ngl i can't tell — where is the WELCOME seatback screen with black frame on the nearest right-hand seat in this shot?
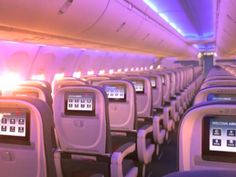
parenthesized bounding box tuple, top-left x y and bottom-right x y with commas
(202, 116, 236, 162)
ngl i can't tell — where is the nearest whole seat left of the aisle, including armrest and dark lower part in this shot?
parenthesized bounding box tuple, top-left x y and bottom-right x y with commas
(53, 85, 138, 177)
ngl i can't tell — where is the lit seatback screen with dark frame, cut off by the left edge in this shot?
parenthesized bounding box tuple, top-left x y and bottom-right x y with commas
(0, 108, 30, 145)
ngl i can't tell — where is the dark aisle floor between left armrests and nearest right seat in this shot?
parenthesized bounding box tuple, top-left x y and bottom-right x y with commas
(147, 128, 178, 177)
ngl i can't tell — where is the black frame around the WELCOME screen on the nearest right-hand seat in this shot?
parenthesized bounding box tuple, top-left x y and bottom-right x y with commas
(201, 115, 236, 163)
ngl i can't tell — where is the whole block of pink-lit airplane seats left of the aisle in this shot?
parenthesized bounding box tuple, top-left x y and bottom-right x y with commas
(0, 67, 203, 177)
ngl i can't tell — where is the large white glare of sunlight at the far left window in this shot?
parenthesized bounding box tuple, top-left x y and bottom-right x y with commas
(0, 72, 22, 95)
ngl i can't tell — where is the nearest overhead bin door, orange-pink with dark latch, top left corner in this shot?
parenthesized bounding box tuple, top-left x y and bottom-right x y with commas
(0, 0, 109, 36)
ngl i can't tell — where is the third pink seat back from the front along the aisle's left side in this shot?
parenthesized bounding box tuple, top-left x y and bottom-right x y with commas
(125, 76, 152, 117)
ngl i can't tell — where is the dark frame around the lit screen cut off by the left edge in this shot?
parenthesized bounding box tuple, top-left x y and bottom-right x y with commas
(0, 108, 30, 145)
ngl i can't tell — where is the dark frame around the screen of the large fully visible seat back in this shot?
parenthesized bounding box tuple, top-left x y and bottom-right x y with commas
(64, 92, 96, 116)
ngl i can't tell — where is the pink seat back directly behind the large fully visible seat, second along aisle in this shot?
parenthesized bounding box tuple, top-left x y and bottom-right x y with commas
(98, 80, 136, 130)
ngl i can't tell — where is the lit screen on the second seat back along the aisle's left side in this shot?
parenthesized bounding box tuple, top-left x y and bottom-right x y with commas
(104, 84, 126, 102)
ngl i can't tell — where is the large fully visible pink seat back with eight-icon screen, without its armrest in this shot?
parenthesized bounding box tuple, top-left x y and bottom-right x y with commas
(53, 85, 111, 154)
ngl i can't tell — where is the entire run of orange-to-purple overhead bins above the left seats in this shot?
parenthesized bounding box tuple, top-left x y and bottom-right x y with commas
(0, 0, 196, 56)
